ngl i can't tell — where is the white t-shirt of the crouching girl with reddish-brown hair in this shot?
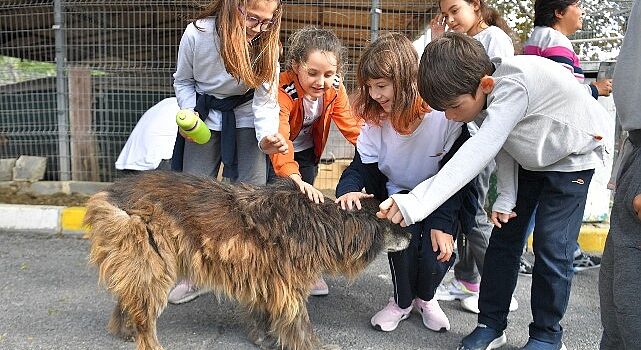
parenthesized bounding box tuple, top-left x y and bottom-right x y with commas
(356, 111, 462, 194)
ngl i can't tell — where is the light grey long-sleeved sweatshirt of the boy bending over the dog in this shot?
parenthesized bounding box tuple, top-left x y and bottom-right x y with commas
(392, 56, 613, 225)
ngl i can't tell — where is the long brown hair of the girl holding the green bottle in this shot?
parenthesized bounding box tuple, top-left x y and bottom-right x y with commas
(194, 0, 283, 88)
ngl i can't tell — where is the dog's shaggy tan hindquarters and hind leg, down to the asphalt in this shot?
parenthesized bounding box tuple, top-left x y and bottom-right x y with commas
(90, 203, 176, 350)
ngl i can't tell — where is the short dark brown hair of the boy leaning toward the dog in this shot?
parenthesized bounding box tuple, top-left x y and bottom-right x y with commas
(418, 32, 494, 111)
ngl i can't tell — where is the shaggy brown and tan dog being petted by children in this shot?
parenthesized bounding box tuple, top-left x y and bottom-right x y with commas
(85, 171, 409, 350)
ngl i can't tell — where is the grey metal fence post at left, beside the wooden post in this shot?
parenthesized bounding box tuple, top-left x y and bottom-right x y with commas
(52, 0, 71, 181)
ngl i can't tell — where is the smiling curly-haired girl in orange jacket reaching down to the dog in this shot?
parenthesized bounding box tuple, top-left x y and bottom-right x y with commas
(270, 27, 360, 295)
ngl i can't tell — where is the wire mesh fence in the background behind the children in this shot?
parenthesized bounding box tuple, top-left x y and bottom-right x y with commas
(0, 0, 438, 188)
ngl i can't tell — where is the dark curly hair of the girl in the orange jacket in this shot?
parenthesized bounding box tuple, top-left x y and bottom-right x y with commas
(285, 26, 347, 74)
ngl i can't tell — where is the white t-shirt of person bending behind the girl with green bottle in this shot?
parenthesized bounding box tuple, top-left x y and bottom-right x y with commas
(116, 97, 180, 170)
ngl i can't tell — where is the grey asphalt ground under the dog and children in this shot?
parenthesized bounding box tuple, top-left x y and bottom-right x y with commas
(0, 232, 601, 350)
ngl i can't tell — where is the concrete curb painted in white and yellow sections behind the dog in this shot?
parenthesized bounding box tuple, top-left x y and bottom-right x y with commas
(0, 204, 610, 253)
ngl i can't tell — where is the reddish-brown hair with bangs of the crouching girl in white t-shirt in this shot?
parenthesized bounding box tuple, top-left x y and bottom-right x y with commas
(354, 33, 429, 133)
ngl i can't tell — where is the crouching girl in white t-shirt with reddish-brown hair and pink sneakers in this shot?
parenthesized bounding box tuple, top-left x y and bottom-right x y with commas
(336, 33, 469, 332)
